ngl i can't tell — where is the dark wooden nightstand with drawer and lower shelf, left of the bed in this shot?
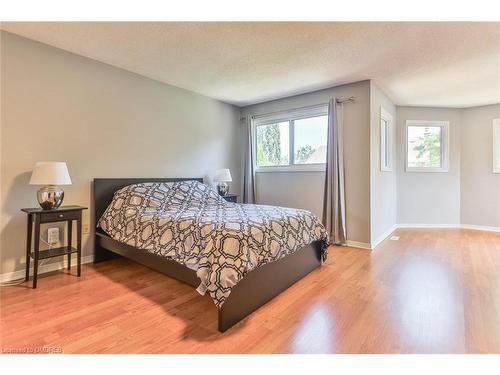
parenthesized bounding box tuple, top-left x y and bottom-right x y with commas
(21, 206, 87, 288)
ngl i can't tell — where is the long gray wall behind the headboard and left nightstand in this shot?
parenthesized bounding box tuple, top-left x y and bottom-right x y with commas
(0, 32, 241, 273)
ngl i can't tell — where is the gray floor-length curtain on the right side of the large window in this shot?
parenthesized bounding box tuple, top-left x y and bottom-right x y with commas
(323, 99, 346, 245)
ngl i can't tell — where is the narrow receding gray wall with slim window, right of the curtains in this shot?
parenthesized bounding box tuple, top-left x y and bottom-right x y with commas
(370, 81, 397, 246)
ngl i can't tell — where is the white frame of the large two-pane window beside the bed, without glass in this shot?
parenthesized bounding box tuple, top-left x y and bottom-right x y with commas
(252, 104, 328, 173)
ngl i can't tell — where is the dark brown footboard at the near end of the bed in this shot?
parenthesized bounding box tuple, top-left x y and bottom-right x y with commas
(218, 242, 321, 332)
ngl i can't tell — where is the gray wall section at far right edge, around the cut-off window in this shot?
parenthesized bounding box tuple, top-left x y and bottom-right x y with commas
(460, 104, 500, 228)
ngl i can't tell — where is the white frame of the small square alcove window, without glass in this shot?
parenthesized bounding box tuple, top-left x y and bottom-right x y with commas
(405, 120, 450, 173)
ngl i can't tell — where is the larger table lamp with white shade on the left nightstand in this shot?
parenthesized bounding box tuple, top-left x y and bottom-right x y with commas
(30, 161, 71, 210)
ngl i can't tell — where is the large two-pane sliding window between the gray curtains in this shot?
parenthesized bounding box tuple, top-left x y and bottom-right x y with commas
(254, 105, 328, 172)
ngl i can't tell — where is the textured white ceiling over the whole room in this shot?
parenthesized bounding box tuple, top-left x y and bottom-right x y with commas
(2, 22, 500, 107)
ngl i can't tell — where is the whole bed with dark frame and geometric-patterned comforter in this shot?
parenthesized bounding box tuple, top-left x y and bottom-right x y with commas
(93, 178, 327, 332)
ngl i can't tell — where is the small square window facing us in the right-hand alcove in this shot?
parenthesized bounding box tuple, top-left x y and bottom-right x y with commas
(406, 120, 449, 172)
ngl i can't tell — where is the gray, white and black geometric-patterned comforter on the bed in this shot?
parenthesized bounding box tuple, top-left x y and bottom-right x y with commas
(98, 181, 328, 308)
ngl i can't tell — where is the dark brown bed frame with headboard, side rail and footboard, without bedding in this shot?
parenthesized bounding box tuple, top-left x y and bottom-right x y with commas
(93, 178, 321, 332)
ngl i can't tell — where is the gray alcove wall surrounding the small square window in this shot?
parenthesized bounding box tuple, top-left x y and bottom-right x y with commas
(397, 107, 460, 224)
